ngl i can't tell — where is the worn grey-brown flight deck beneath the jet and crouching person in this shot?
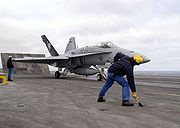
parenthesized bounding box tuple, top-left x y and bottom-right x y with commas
(0, 75, 180, 128)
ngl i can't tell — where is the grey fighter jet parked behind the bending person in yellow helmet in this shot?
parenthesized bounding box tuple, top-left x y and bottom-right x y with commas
(13, 35, 150, 80)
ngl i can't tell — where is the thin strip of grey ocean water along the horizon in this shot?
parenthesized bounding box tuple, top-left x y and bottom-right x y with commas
(134, 71, 180, 77)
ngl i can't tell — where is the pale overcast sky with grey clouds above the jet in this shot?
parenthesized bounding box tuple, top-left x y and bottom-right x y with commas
(0, 0, 180, 71)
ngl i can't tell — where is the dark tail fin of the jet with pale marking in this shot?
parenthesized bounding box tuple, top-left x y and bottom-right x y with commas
(41, 35, 59, 56)
